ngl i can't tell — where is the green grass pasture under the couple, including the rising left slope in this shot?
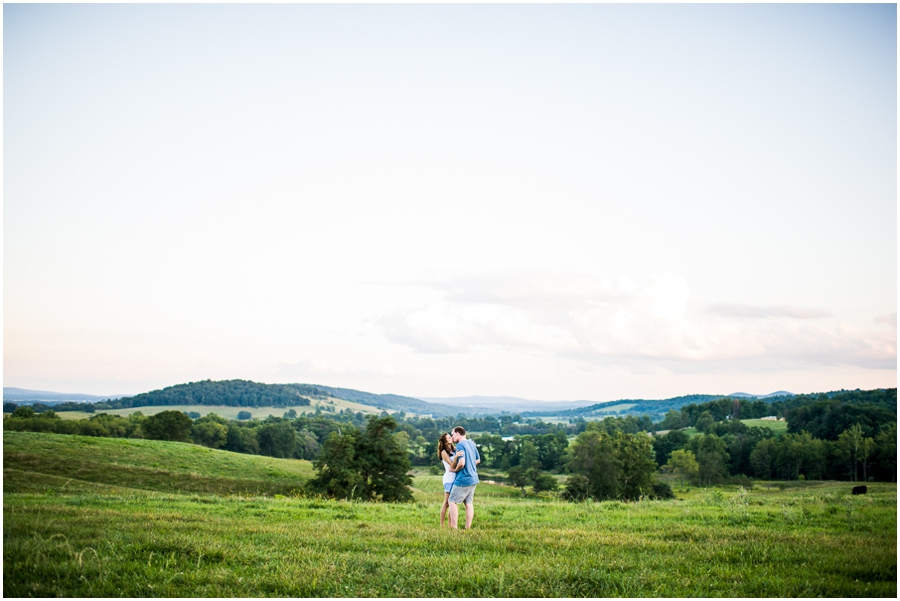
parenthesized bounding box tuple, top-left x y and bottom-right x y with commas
(3, 432, 897, 598)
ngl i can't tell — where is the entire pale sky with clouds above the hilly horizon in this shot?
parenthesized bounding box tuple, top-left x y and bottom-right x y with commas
(3, 4, 897, 402)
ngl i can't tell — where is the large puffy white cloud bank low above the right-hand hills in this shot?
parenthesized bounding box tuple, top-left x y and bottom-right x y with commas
(378, 274, 897, 371)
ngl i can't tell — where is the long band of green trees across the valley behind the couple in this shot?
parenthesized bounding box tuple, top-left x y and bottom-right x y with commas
(4, 389, 897, 500)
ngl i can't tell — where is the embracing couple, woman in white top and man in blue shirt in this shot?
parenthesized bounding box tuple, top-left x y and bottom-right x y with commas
(438, 426, 481, 530)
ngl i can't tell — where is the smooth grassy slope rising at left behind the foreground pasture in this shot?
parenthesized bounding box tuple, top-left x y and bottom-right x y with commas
(3, 431, 313, 494)
